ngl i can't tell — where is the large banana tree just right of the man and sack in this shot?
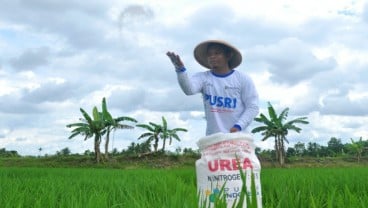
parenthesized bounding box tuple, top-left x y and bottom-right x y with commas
(252, 102, 309, 166)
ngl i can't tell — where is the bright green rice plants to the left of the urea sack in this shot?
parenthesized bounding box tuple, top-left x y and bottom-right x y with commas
(0, 168, 196, 207)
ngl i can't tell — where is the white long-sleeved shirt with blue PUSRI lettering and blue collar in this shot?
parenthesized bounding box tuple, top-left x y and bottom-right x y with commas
(177, 70, 259, 135)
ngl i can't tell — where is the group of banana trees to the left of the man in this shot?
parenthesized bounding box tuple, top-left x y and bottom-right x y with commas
(66, 98, 187, 163)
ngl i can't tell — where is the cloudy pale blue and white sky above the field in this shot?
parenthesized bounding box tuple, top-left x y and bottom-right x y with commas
(0, 0, 368, 155)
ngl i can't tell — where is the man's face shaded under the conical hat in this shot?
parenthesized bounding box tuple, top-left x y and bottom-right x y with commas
(207, 45, 229, 70)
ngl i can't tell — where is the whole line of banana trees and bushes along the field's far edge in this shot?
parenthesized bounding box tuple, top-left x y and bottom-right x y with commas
(0, 98, 368, 166)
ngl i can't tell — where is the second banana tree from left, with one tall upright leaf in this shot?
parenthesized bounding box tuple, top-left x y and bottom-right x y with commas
(102, 98, 137, 160)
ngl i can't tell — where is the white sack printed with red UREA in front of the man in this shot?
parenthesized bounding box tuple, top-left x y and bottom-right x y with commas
(196, 133, 262, 208)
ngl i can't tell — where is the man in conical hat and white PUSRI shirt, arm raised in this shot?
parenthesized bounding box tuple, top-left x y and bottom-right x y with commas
(167, 40, 259, 135)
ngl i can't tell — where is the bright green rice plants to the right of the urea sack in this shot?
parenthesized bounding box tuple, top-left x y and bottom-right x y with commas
(262, 167, 368, 208)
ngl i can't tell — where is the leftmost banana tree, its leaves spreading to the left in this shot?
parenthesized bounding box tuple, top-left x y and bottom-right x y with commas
(66, 106, 105, 163)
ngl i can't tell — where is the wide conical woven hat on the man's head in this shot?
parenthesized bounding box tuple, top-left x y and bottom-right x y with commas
(194, 40, 242, 69)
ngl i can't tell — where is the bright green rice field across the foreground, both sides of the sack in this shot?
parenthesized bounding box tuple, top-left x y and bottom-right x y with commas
(0, 167, 368, 208)
